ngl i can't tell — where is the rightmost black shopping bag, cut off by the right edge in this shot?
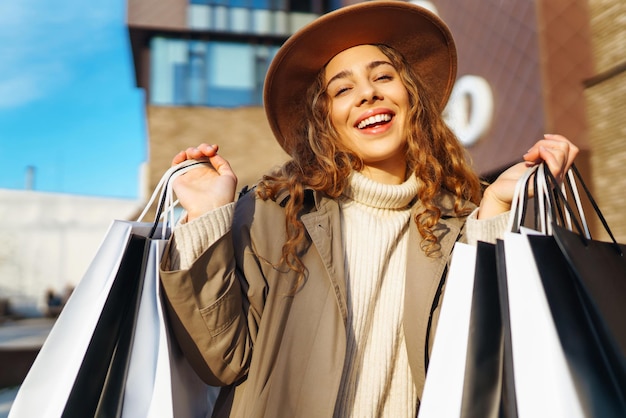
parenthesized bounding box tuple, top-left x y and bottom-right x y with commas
(535, 166, 626, 416)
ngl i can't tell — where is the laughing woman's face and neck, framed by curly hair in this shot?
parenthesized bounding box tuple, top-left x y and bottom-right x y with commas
(325, 45, 409, 183)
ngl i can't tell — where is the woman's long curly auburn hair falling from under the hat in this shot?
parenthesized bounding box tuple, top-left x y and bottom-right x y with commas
(256, 45, 482, 275)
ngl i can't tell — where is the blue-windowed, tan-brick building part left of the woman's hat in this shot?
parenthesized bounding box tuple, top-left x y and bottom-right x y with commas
(128, 0, 339, 198)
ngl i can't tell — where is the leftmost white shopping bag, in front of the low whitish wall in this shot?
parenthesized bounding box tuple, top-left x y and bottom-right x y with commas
(9, 221, 152, 418)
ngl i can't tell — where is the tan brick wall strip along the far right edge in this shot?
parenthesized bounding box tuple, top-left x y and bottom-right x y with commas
(585, 0, 626, 243)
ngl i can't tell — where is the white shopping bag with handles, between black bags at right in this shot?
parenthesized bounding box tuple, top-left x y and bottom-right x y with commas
(496, 165, 584, 417)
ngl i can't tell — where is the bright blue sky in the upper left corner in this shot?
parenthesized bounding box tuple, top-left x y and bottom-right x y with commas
(0, 0, 147, 198)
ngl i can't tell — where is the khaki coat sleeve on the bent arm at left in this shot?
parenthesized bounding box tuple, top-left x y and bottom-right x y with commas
(161, 193, 266, 386)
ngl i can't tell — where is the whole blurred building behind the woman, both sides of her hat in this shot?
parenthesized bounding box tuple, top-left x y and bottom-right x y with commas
(128, 0, 626, 242)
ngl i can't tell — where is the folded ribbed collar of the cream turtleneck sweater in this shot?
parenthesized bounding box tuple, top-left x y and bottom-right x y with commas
(343, 171, 418, 209)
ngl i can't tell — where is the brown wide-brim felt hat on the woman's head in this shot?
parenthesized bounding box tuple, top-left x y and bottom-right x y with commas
(263, 1, 457, 153)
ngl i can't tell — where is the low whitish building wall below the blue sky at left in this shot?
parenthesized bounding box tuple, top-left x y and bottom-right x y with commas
(0, 189, 141, 319)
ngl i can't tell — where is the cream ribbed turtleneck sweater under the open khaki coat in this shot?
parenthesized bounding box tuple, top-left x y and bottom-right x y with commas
(335, 172, 417, 418)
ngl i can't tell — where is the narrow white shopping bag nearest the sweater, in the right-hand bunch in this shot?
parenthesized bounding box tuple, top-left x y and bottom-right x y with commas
(418, 242, 476, 418)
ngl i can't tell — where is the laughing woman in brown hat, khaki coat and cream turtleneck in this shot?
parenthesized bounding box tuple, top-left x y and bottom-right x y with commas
(162, 2, 578, 417)
